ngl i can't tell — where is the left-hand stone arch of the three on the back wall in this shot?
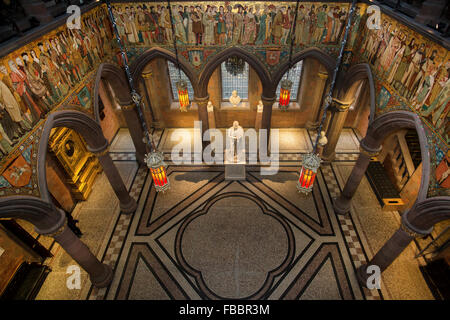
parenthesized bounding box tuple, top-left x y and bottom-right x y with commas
(130, 47, 198, 94)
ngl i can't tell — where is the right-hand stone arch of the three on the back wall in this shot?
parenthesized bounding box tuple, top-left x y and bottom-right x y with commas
(270, 48, 336, 96)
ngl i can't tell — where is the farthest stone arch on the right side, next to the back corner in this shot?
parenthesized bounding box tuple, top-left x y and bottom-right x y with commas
(337, 63, 376, 125)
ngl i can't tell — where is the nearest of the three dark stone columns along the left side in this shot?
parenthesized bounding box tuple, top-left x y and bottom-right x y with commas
(52, 223, 113, 288)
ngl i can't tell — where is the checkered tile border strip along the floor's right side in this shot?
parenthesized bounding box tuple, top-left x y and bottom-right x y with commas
(322, 165, 382, 300)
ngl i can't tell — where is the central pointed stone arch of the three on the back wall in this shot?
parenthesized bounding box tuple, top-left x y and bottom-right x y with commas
(196, 47, 272, 98)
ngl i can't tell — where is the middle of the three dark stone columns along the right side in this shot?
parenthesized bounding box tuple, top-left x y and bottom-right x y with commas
(333, 138, 381, 214)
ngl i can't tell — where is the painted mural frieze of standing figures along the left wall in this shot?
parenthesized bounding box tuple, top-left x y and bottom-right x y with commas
(0, 6, 117, 172)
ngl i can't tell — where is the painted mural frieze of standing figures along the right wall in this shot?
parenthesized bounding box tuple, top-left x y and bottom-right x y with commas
(352, 5, 450, 196)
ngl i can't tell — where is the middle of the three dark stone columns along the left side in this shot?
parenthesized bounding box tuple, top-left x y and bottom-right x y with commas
(88, 147, 137, 214)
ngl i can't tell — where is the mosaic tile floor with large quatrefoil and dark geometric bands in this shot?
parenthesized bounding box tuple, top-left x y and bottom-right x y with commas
(38, 128, 432, 300)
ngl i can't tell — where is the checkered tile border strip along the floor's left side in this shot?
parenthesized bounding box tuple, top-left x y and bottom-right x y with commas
(87, 166, 148, 300)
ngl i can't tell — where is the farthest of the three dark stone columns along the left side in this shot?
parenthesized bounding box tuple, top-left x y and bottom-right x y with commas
(119, 101, 147, 164)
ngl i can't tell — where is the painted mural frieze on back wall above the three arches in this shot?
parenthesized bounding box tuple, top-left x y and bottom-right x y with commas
(113, 1, 349, 72)
